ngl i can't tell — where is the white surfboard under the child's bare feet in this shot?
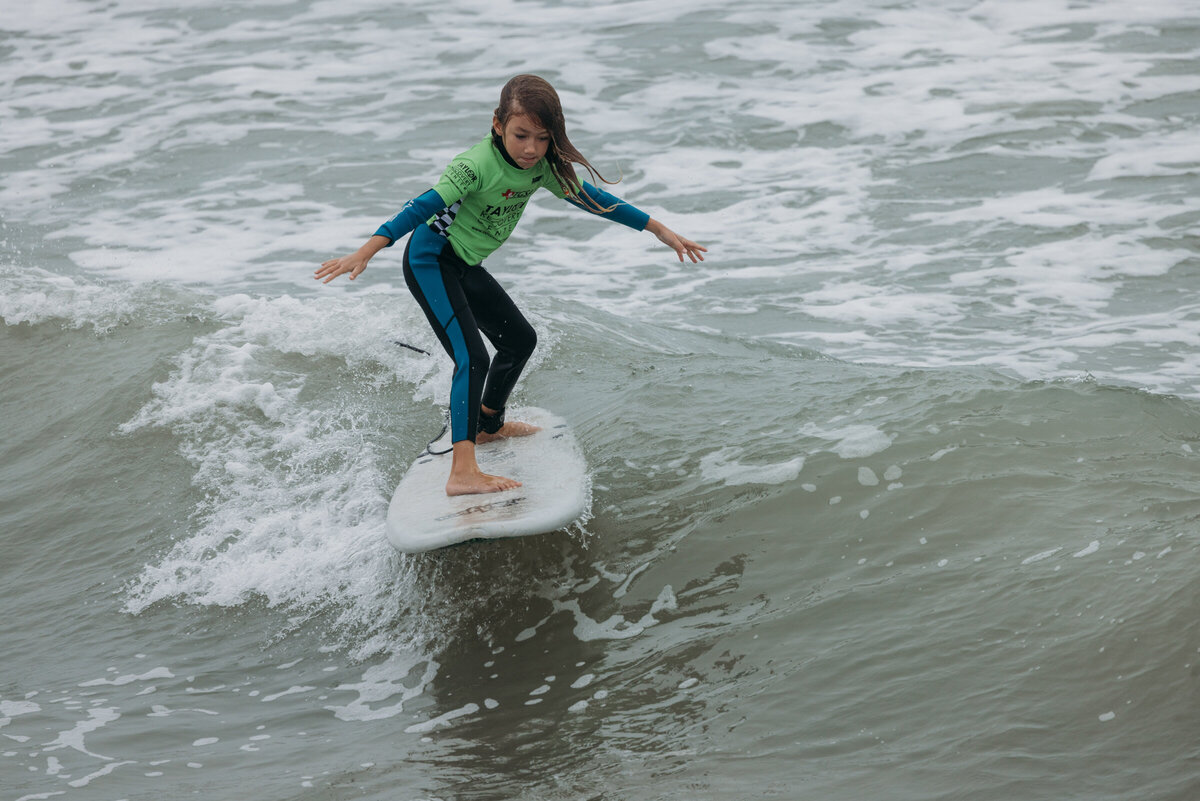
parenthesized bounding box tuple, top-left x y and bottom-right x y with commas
(386, 406, 590, 554)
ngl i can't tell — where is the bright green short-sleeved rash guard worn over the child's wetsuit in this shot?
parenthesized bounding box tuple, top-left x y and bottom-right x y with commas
(430, 134, 566, 264)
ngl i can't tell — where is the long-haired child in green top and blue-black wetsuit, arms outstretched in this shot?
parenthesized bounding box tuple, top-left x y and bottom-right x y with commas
(316, 76, 707, 495)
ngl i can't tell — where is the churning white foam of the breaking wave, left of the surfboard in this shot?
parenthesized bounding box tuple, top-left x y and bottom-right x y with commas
(121, 294, 525, 651)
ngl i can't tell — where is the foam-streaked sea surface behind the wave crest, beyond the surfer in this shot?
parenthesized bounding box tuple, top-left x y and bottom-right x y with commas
(7, 0, 1200, 395)
